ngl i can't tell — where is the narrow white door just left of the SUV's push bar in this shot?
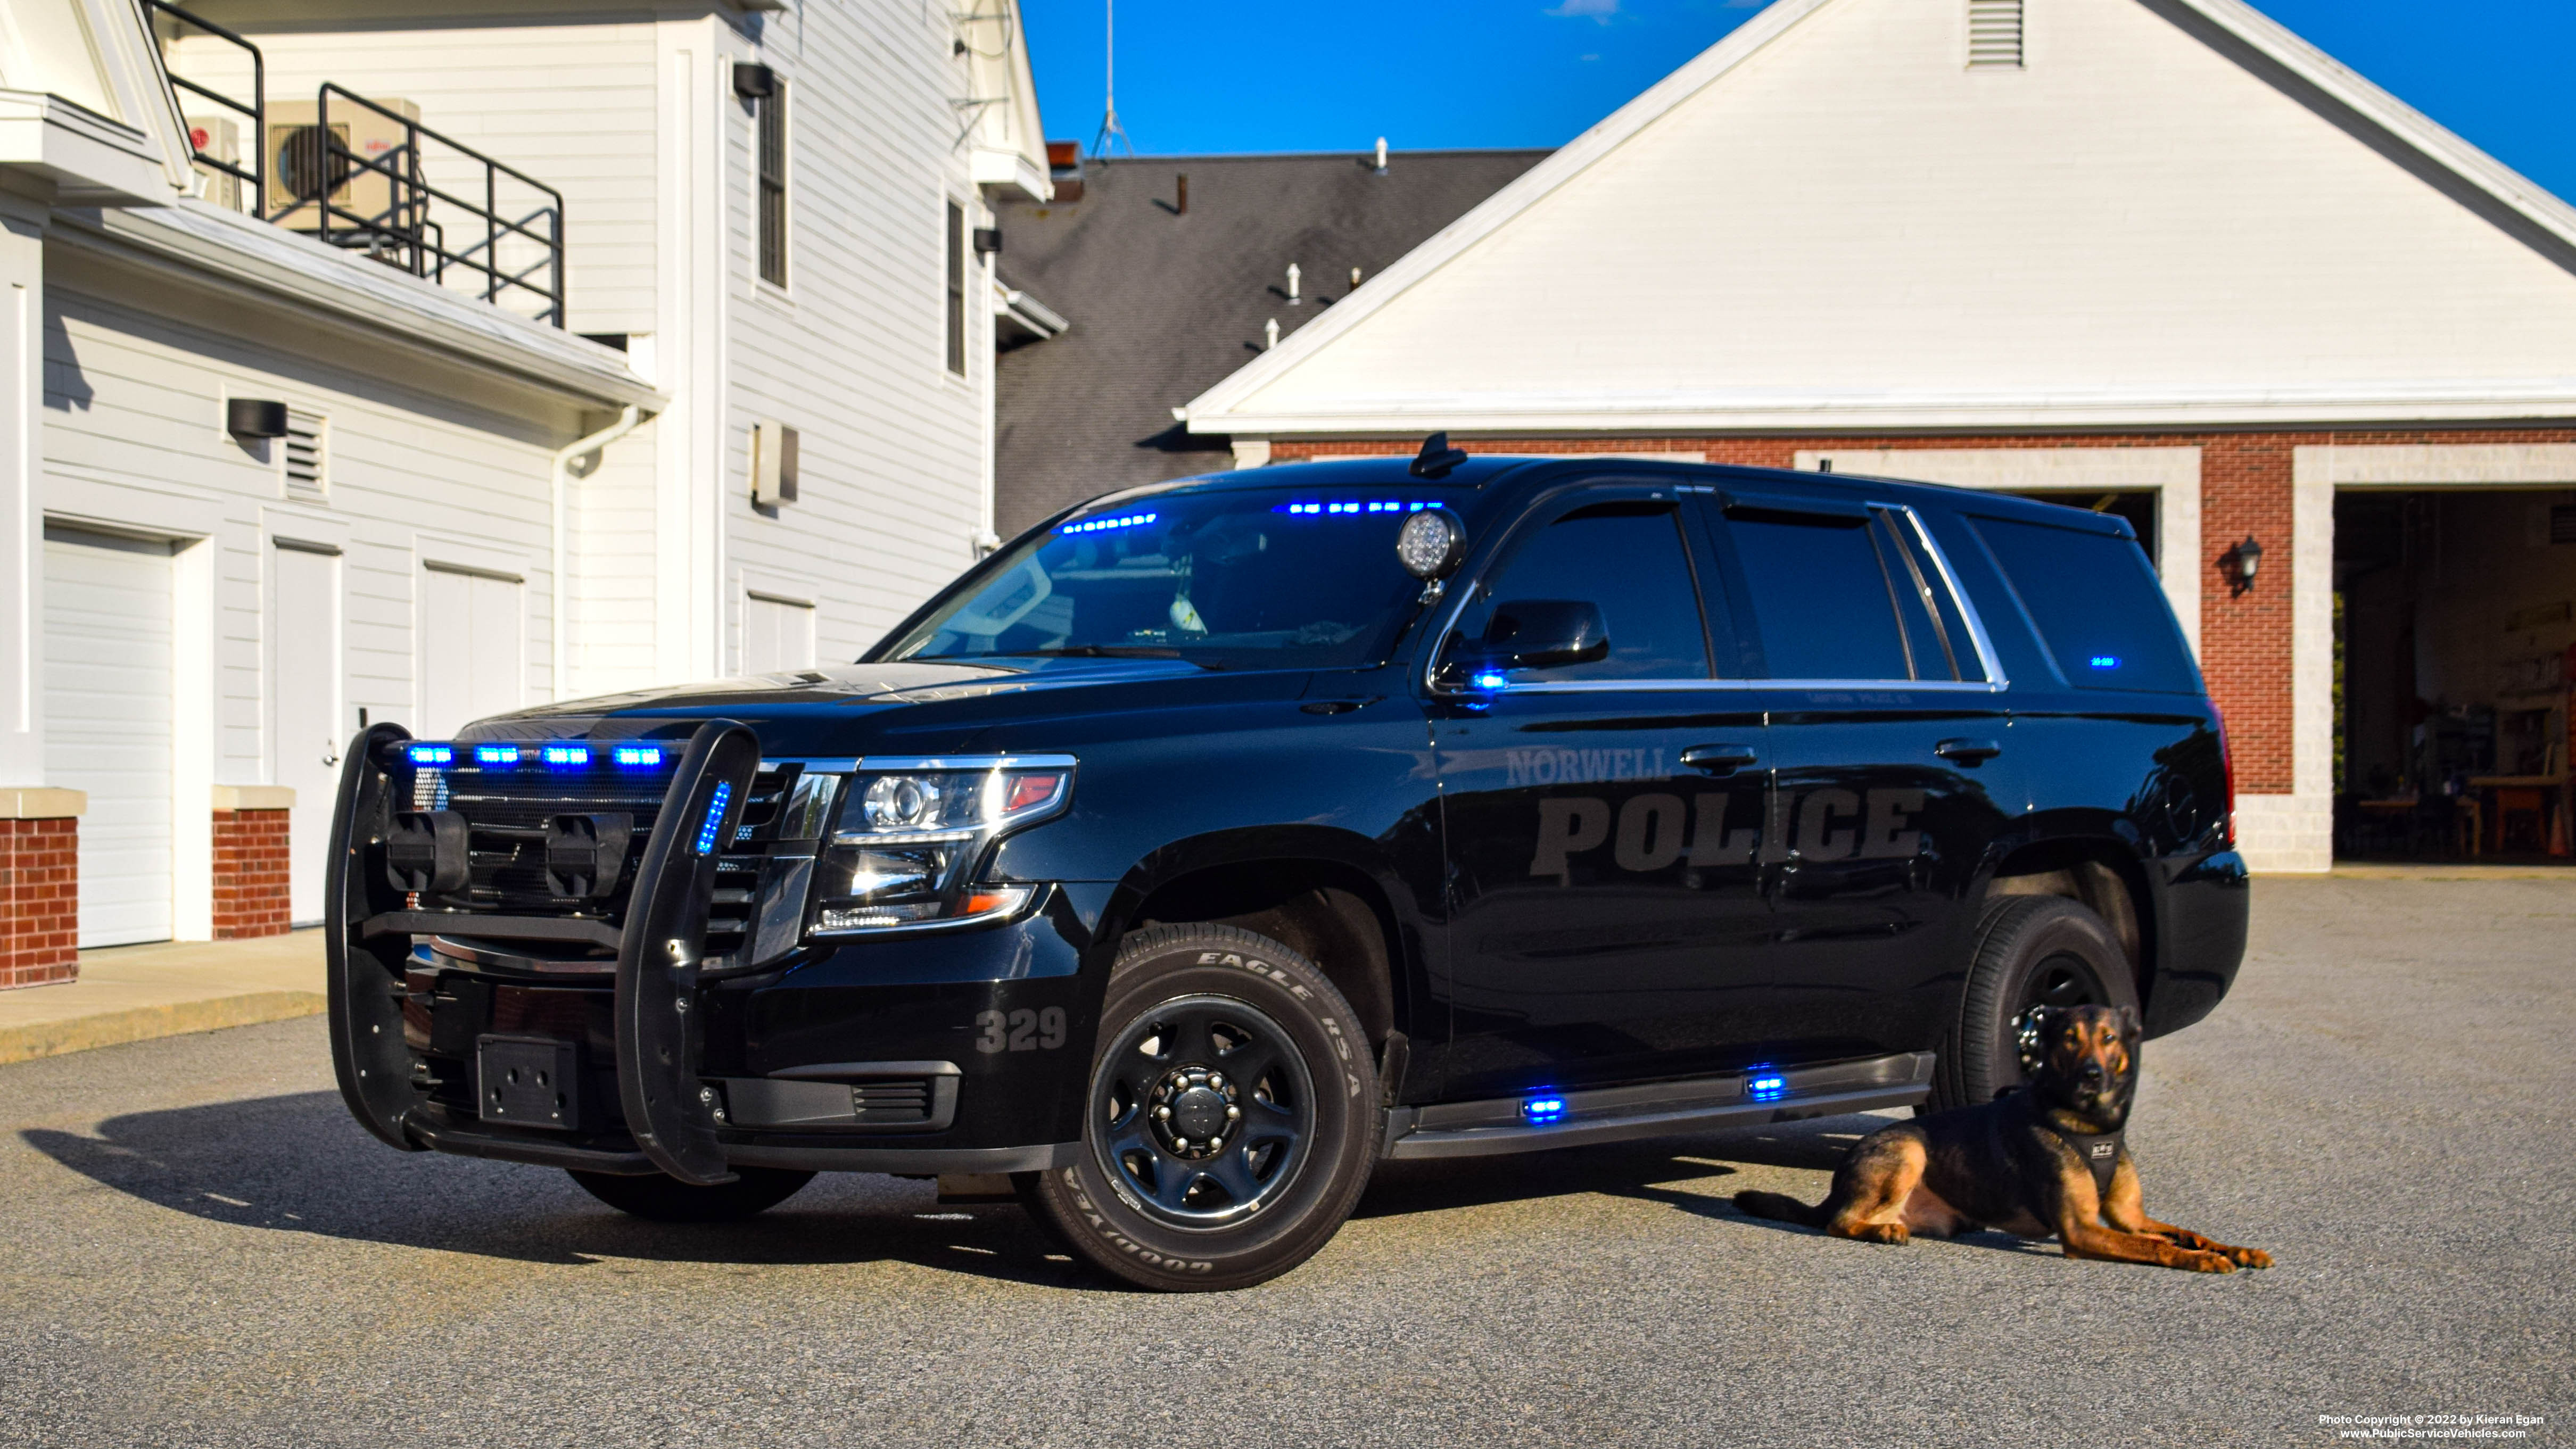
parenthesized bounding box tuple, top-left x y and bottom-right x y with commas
(268, 543, 356, 926)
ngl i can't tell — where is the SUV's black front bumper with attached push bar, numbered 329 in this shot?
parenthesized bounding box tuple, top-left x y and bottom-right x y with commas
(327, 726, 1100, 1181)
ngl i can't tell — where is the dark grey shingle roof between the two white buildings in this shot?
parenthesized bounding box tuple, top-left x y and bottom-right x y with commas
(994, 152, 1548, 535)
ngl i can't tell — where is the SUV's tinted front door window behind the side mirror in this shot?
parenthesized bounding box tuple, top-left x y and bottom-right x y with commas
(1448, 499, 1708, 680)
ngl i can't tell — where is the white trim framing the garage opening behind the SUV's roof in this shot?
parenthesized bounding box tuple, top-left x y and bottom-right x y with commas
(1795, 448, 2200, 659)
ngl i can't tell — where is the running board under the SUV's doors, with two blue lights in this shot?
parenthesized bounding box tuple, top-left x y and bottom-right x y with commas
(1383, 1053, 1932, 1158)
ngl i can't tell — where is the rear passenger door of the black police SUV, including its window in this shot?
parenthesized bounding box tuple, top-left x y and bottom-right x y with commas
(1713, 492, 2020, 1061)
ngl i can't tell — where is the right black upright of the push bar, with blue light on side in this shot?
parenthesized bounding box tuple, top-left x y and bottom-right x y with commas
(616, 721, 760, 1187)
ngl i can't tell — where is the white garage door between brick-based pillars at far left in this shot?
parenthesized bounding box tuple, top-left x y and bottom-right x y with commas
(44, 525, 175, 947)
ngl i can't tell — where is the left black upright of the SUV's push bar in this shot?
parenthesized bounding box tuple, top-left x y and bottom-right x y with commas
(322, 723, 423, 1153)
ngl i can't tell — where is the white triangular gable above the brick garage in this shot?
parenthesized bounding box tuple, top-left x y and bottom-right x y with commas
(1190, 0, 2576, 437)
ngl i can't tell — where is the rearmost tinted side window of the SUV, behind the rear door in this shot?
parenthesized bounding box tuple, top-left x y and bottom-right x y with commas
(1968, 517, 2200, 695)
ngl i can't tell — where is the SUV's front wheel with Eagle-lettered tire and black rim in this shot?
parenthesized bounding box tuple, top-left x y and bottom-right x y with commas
(1020, 926, 1378, 1292)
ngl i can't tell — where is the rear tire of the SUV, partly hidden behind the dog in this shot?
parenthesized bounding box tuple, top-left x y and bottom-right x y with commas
(1924, 896, 2138, 1112)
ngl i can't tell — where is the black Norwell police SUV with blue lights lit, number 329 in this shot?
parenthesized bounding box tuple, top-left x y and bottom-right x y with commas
(330, 440, 2246, 1289)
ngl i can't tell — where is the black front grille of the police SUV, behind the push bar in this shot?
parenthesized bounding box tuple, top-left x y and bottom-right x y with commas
(410, 746, 801, 968)
